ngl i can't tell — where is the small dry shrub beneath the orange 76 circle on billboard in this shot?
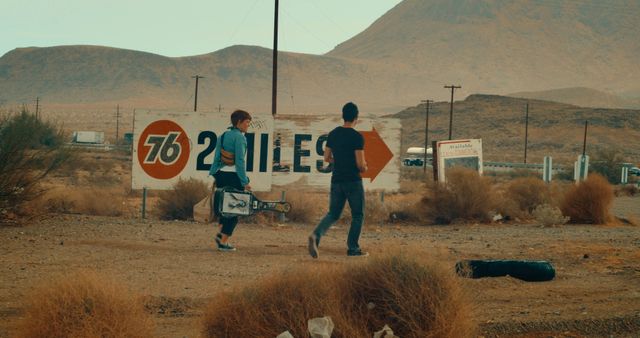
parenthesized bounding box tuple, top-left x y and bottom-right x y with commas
(157, 178, 211, 220)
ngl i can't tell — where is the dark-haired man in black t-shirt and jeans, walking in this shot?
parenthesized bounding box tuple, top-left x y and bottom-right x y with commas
(309, 102, 369, 258)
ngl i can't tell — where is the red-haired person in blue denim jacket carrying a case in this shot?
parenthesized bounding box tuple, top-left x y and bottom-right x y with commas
(209, 110, 251, 251)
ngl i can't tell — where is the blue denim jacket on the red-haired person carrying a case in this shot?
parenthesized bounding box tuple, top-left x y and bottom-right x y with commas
(209, 127, 249, 187)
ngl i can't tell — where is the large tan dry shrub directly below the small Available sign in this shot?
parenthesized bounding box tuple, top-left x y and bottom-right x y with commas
(422, 168, 496, 224)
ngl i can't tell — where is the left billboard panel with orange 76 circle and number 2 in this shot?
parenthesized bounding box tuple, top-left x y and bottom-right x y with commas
(131, 112, 273, 191)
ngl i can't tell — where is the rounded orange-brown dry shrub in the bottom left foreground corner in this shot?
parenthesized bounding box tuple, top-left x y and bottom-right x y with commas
(17, 272, 154, 338)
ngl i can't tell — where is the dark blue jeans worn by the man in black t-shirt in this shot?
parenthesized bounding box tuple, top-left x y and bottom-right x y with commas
(313, 181, 364, 252)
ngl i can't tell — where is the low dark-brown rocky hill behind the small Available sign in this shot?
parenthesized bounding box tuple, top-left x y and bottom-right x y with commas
(393, 95, 640, 165)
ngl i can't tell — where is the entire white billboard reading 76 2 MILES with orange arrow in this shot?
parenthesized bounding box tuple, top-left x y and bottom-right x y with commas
(132, 112, 400, 191)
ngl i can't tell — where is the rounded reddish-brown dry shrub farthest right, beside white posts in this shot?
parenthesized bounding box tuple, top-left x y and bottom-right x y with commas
(560, 174, 614, 224)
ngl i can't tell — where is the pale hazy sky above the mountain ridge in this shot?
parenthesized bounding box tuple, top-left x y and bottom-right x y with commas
(0, 0, 401, 56)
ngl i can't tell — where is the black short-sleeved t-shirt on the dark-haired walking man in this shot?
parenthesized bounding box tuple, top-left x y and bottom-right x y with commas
(327, 127, 364, 183)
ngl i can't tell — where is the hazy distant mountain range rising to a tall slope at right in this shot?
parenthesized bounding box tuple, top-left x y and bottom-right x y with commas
(0, 0, 640, 113)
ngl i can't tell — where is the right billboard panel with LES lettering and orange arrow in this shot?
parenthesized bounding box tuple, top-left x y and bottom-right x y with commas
(273, 115, 401, 191)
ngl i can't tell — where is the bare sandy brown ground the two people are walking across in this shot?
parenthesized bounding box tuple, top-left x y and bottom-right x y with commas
(0, 197, 640, 337)
